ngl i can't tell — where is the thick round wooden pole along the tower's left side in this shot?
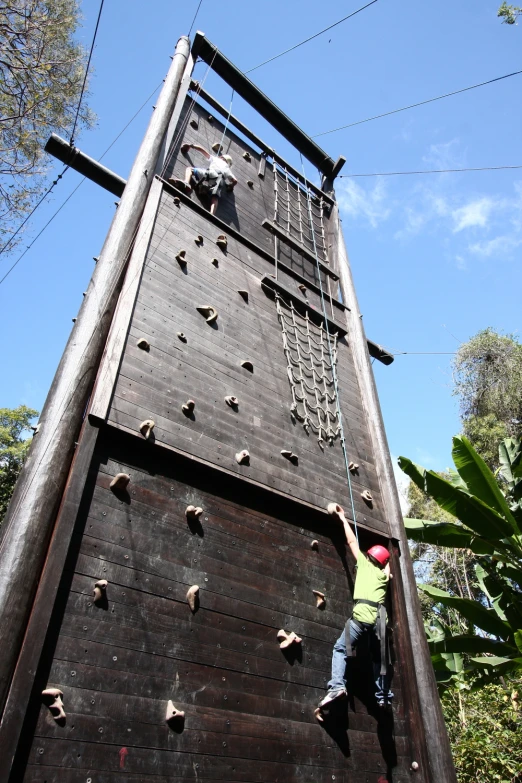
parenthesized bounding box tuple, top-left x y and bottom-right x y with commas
(0, 36, 190, 709)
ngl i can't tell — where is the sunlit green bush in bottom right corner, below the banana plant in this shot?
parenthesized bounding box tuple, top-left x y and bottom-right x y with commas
(442, 678, 522, 783)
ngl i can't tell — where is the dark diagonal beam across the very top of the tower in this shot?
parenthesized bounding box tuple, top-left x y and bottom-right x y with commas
(193, 31, 340, 177)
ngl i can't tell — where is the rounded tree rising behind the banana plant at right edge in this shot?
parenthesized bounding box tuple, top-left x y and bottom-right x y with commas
(453, 328, 522, 470)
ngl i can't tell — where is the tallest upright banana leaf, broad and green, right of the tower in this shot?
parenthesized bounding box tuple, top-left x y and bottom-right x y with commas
(452, 435, 520, 533)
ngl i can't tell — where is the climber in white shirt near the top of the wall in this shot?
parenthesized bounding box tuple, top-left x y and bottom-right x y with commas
(169, 144, 237, 215)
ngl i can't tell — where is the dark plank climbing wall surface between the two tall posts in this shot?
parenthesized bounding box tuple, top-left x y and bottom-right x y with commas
(5, 90, 424, 783)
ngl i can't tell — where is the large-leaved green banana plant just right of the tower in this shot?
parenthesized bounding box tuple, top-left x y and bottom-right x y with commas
(399, 436, 522, 688)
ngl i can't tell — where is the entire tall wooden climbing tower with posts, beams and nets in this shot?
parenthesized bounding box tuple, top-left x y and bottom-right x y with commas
(0, 33, 455, 783)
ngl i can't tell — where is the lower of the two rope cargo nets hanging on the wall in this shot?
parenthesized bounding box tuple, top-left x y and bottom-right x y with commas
(275, 292, 341, 448)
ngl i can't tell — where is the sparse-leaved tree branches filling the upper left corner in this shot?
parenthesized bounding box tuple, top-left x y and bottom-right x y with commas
(0, 0, 93, 250)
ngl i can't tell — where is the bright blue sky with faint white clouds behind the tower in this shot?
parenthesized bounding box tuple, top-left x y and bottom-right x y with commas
(0, 0, 522, 490)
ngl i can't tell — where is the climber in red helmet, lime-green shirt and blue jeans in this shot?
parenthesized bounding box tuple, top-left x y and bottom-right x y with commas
(315, 503, 393, 723)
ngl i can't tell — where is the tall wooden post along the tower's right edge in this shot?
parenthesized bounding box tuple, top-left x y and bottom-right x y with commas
(330, 206, 457, 783)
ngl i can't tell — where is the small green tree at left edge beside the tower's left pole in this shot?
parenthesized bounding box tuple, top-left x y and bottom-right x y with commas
(0, 405, 38, 522)
